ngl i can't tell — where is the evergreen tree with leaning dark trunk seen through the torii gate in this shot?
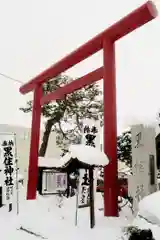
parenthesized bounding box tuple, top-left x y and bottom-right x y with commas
(20, 75, 103, 157)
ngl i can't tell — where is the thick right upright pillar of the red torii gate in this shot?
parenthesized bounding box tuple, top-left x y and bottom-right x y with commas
(103, 40, 118, 216)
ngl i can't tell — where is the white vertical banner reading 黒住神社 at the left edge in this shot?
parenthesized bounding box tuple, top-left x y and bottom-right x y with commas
(0, 133, 16, 209)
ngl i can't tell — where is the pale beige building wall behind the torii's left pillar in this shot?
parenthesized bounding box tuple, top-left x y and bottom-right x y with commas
(0, 124, 61, 184)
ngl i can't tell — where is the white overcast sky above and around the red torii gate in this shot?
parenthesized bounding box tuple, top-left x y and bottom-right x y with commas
(0, 0, 160, 133)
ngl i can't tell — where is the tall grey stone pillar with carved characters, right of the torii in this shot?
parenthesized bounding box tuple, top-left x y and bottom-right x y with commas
(129, 124, 157, 214)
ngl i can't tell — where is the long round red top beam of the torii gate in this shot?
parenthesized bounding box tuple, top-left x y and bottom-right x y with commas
(20, 1, 157, 94)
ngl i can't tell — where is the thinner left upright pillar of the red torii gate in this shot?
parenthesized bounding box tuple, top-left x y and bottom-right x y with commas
(27, 86, 42, 200)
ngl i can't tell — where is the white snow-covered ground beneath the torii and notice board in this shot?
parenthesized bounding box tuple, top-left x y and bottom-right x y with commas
(0, 186, 131, 240)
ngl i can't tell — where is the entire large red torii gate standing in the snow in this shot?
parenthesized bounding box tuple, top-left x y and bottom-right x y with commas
(20, 1, 158, 216)
